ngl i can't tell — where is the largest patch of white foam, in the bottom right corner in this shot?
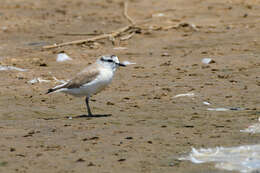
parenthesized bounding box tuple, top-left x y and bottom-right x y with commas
(179, 145, 260, 173)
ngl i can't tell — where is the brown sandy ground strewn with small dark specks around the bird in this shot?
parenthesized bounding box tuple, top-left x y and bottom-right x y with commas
(0, 0, 260, 173)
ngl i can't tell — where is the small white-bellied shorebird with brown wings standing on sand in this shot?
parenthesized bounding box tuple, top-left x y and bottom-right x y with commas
(47, 55, 126, 116)
